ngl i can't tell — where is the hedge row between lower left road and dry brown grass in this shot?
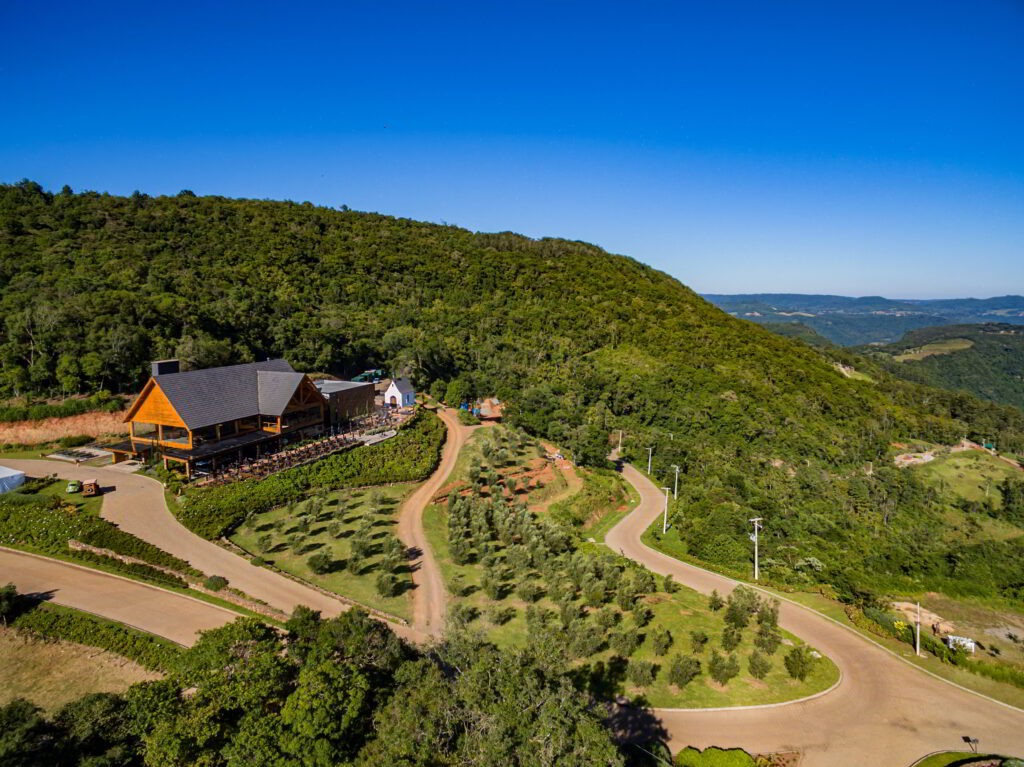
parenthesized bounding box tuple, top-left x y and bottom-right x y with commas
(10, 604, 181, 672)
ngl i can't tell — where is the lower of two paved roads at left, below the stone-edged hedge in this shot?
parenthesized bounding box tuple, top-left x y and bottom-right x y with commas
(0, 548, 239, 647)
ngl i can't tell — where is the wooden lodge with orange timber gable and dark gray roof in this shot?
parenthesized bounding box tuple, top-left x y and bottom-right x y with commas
(108, 359, 328, 477)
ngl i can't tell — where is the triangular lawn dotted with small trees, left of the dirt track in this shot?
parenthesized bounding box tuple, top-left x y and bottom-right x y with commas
(231, 484, 416, 620)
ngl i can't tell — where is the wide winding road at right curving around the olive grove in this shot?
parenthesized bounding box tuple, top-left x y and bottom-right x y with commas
(605, 464, 1024, 767)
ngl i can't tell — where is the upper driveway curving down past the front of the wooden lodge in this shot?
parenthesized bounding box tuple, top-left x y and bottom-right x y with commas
(0, 459, 423, 641)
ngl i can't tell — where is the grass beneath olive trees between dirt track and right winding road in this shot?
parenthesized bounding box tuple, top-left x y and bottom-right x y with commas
(424, 505, 838, 708)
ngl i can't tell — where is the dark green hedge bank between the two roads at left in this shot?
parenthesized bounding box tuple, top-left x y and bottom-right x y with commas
(0, 493, 202, 576)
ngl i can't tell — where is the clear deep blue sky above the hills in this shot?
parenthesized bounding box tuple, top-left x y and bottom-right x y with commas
(0, 0, 1024, 298)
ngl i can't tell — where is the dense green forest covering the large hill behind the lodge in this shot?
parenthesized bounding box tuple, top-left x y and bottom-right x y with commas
(6, 181, 1024, 596)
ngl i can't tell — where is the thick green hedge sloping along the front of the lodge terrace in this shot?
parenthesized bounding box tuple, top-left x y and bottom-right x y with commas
(175, 411, 445, 540)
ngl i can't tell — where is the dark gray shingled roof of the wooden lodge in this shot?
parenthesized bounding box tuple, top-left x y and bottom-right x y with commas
(154, 359, 302, 429)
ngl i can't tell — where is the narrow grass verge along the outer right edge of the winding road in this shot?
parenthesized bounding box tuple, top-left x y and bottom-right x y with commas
(643, 523, 1024, 708)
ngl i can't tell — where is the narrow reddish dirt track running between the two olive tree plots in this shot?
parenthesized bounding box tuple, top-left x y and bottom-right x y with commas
(396, 410, 472, 637)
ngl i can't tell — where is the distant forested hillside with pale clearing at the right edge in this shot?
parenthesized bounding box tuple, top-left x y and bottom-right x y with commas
(856, 323, 1024, 409)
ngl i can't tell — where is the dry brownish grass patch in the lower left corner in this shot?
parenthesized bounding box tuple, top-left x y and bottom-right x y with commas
(0, 627, 161, 714)
